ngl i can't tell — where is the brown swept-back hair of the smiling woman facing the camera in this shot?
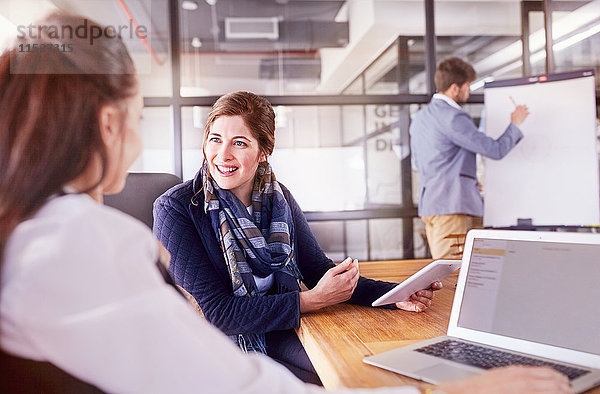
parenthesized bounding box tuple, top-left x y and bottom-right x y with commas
(203, 91, 275, 157)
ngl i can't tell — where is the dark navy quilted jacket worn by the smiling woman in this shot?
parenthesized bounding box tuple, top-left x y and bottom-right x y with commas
(154, 174, 395, 335)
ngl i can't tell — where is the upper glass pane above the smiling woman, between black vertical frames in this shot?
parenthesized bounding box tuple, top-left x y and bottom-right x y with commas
(180, 0, 434, 96)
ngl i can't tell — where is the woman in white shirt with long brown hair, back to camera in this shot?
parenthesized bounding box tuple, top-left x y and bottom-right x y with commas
(0, 14, 568, 393)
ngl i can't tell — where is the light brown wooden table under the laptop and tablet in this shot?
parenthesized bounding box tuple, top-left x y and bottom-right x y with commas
(297, 260, 600, 394)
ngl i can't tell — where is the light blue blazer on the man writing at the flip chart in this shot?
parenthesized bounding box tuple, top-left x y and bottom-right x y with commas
(410, 96, 523, 217)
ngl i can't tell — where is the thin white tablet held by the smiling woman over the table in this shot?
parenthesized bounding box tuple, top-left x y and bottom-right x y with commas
(373, 260, 461, 306)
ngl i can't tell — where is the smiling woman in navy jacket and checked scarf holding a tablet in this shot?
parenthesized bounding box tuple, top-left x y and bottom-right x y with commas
(154, 92, 441, 383)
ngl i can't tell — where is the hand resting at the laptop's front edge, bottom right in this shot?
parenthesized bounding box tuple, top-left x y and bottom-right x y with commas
(437, 366, 573, 394)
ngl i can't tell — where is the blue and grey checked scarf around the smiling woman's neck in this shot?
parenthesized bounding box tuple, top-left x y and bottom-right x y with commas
(200, 162, 302, 354)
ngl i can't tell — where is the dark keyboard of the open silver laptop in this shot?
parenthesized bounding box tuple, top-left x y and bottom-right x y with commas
(415, 339, 590, 380)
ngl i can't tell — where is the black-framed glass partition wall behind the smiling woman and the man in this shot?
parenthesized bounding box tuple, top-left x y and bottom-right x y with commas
(0, 0, 600, 260)
